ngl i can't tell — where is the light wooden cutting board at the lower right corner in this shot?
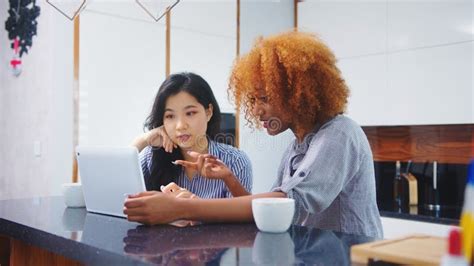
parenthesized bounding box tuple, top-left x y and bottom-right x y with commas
(351, 235, 448, 265)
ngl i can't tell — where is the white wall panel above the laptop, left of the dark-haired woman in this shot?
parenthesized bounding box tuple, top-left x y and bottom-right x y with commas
(79, 1, 165, 146)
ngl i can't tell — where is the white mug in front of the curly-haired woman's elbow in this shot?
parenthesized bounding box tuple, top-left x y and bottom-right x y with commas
(252, 198, 295, 233)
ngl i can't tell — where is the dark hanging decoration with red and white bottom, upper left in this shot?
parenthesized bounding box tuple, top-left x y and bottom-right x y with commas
(5, 0, 40, 76)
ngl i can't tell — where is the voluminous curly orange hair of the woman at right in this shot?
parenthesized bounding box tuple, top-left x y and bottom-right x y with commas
(229, 32, 349, 131)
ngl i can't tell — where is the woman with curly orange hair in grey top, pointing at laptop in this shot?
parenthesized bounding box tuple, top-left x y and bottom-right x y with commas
(124, 32, 383, 237)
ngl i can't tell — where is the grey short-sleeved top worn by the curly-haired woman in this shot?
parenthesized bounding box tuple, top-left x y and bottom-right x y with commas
(272, 115, 383, 238)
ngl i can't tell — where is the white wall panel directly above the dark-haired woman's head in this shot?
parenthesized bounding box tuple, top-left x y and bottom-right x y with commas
(171, 0, 237, 113)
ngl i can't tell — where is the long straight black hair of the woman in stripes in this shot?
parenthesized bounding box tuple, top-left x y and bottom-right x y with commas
(144, 72, 221, 191)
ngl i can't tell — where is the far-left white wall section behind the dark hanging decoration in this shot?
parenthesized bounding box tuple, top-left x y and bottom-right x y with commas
(0, 1, 73, 199)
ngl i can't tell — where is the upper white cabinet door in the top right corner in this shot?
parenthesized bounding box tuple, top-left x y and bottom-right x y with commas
(386, 0, 474, 51)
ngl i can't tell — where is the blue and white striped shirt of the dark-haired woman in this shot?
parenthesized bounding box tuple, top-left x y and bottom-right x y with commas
(140, 141, 252, 199)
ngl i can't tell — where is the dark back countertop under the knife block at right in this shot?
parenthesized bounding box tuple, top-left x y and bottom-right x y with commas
(378, 202, 462, 225)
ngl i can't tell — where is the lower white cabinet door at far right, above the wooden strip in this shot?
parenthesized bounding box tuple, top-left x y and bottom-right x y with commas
(386, 42, 474, 125)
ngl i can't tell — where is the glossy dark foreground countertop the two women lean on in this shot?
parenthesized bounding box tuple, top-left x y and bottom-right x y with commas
(0, 197, 375, 265)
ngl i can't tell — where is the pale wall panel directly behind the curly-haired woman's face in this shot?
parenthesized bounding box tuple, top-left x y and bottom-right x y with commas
(239, 0, 294, 193)
